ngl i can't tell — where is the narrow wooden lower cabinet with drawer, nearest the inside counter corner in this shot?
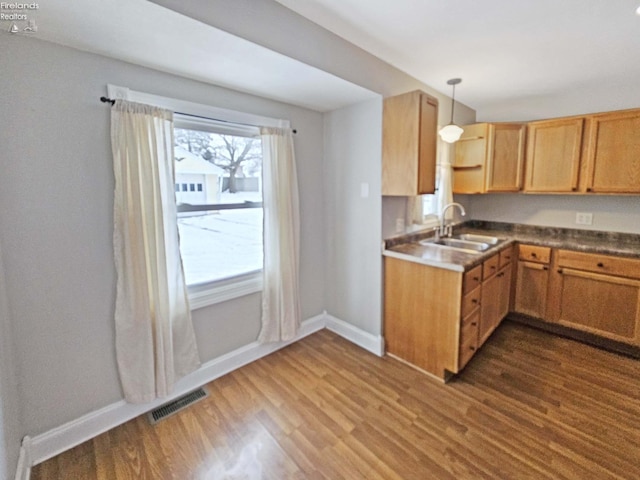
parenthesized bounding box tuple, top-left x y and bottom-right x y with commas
(514, 245, 551, 318)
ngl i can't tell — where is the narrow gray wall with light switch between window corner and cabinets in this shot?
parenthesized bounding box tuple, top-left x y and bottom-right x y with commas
(324, 99, 382, 335)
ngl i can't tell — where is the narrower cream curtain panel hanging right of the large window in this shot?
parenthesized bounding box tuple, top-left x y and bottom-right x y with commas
(258, 127, 300, 343)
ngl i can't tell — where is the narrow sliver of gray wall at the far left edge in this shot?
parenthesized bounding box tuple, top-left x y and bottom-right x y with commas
(0, 247, 21, 480)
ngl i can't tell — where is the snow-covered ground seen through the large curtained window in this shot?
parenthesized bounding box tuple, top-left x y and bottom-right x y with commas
(178, 192, 262, 285)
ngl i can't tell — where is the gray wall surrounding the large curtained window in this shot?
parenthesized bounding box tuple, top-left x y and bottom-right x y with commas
(0, 35, 325, 437)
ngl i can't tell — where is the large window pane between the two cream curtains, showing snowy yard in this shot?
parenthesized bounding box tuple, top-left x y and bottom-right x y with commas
(174, 115, 263, 290)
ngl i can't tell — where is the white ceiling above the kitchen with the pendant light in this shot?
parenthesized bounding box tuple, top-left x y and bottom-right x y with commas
(276, 0, 640, 110)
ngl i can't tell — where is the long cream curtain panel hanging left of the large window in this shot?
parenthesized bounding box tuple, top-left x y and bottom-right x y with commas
(111, 100, 200, 403)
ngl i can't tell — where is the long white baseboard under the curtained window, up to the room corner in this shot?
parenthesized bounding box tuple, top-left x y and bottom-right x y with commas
(28, 314, 326, 466)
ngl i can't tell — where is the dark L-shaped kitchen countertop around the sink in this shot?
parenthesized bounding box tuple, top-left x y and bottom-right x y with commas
(383, 220, 640, 272)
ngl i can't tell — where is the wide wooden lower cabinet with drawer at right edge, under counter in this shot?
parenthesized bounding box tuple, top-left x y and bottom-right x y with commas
(550, 250, 640, 345)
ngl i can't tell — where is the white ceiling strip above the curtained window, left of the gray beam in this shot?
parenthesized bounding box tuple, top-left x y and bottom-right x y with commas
(27, 0, 376, 111)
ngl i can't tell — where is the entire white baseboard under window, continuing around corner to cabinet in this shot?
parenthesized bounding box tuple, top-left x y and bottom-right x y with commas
(25, 312, 384, 468)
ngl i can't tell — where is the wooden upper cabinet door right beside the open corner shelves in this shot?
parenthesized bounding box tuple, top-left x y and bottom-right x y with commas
(486, 123, 525, 192)
